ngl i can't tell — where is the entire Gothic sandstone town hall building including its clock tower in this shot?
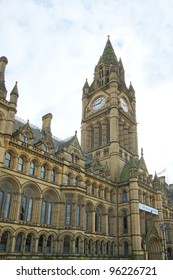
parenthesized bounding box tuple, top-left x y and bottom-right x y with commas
(0, 37, 173, 260)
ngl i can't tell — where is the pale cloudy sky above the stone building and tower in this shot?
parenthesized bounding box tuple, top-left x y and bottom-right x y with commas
(0, 0, 173, 184)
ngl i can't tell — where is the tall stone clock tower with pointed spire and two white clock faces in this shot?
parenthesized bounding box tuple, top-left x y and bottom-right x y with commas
(81, 37, 138, 182)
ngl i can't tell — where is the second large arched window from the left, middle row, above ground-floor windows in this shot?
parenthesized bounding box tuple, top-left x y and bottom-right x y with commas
(20, 189, 33, 222)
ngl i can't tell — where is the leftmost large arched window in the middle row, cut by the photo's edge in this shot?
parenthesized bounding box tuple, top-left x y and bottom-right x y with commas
(0, 190, 11, 219)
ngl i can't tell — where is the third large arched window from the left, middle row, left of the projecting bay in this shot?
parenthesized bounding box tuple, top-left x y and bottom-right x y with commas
(40, 195, 52, 225)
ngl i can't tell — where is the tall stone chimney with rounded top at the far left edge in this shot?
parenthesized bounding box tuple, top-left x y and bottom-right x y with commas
(0, 56, 8, 99)
